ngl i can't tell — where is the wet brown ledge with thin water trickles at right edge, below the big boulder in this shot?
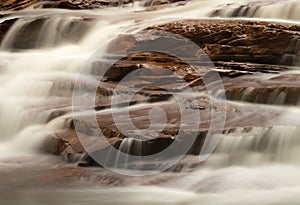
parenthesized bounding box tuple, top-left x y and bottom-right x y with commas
(224, 74, 300, 106)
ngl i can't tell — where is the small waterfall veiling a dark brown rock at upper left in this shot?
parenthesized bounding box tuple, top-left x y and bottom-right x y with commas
(1, 16, 90, 50)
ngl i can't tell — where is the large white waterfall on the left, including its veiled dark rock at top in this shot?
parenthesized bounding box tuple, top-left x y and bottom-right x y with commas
(0, 13, 127, 153)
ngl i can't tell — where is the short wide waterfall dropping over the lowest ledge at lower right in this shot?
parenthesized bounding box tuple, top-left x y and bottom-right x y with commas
(210, 126, 300, 166)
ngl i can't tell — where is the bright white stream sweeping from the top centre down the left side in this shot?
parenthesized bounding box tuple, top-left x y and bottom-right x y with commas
(0, 1, 251, 154)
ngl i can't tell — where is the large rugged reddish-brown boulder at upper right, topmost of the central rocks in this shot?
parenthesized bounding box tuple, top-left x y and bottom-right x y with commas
(110, 20, 300, 65)
